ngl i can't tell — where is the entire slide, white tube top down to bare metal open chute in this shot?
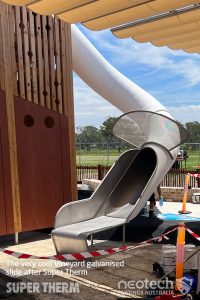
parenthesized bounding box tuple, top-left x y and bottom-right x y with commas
(52, 26, 188, 254)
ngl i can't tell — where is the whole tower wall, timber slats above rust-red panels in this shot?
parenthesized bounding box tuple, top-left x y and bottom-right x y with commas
(0, 1, 77, 234)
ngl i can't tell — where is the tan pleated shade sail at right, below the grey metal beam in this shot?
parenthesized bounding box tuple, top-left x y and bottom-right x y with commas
(112, 5, 200, 53)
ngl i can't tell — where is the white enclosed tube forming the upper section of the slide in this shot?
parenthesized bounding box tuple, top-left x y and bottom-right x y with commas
(72, 25, 171, 117)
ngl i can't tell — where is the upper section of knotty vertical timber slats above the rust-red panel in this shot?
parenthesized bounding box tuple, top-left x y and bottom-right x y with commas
(0, 2, 72, 115)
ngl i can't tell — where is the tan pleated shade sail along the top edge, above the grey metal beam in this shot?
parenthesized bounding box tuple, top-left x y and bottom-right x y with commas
(3, 0, 198, 25)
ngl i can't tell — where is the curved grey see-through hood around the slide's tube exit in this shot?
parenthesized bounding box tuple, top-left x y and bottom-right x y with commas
(113, 111, 190, 151)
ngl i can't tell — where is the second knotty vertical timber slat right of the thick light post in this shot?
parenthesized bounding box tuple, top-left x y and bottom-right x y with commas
(22, 7, 32, 101)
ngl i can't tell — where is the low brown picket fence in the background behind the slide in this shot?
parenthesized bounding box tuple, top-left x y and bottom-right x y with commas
(77, 165, 200, 187)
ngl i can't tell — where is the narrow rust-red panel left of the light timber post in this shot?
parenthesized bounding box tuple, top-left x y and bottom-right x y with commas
(0, 90, 13, 235)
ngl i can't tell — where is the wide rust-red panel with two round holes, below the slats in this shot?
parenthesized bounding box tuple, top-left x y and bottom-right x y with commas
(15, 98, 68, 231)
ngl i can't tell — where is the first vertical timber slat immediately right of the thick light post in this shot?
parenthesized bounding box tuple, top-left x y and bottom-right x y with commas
(15, 6, 26, 99)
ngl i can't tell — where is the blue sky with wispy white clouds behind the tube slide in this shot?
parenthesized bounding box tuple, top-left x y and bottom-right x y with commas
(74, 25, 200, 128)
